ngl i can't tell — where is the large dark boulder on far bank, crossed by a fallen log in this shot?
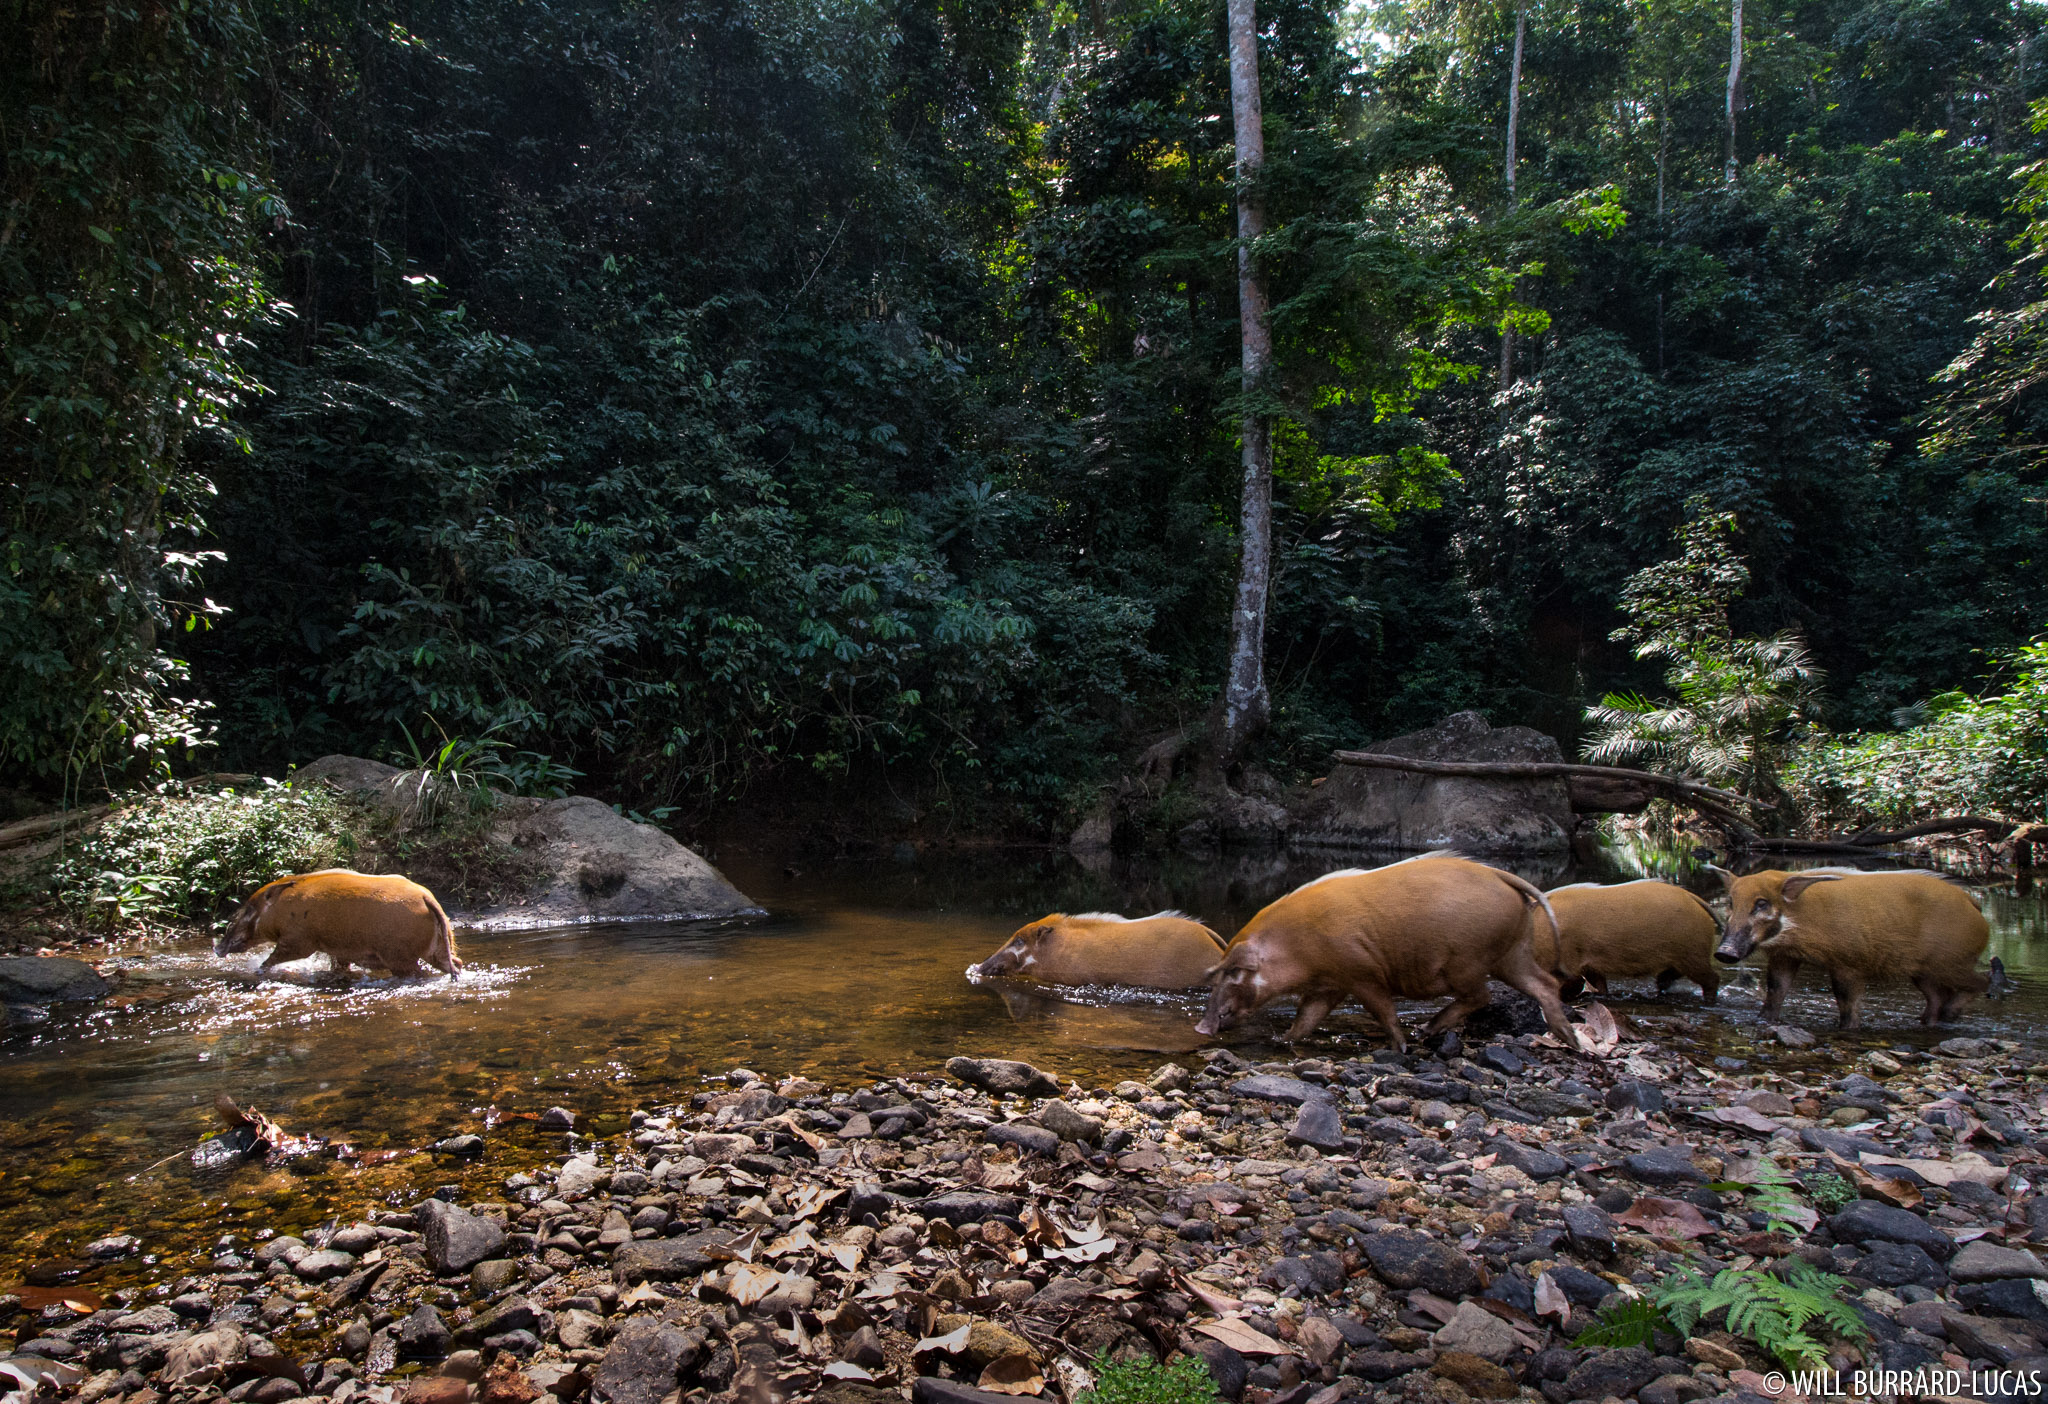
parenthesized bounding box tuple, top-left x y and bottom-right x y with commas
(1288, 712, 1571, 853)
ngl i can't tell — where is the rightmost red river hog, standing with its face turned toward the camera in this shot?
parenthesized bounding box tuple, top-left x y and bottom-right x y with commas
(1714, 868, 1991, 1029)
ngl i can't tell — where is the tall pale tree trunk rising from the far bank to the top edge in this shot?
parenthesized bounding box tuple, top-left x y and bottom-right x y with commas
(1210, 0, 1274, 770)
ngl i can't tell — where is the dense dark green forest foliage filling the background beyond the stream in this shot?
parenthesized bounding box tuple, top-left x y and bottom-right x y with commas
(0, 0, 2048, 823)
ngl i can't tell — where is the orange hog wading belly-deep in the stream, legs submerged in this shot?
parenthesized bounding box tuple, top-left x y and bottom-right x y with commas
(967, 911, 1223, 991)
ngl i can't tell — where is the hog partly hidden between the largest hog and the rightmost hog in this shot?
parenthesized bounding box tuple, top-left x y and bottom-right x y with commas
(1534, 878, 1720, 1005)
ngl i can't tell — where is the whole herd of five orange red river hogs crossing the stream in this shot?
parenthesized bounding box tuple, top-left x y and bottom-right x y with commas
(215, 853, 1991, 1050)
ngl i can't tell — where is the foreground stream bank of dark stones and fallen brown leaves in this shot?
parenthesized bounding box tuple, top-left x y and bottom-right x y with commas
(12, 1017, 2048, 1404)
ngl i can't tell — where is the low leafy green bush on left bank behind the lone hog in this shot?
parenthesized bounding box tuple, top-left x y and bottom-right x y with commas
(49, 780, 356, 929)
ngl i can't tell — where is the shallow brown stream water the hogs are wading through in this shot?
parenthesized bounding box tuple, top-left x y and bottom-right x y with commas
(0, 849, 2048, 1289)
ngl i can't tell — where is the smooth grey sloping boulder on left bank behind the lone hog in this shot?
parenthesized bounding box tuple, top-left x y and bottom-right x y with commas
(293, 755, 762, 931)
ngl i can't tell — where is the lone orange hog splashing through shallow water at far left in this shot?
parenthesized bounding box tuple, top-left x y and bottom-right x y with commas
(213, 868, 463, 980)
